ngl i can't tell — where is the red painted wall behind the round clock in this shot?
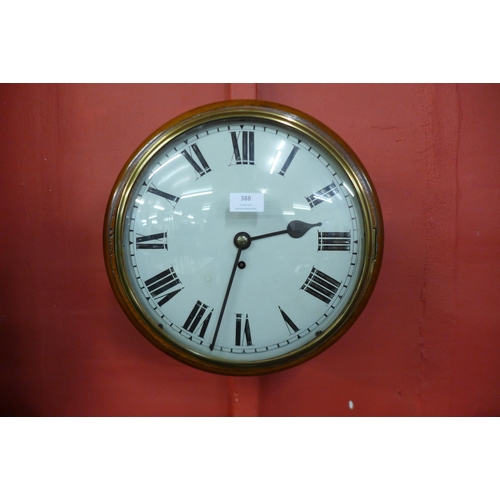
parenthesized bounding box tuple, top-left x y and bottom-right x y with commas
(0, 84, 500, 416)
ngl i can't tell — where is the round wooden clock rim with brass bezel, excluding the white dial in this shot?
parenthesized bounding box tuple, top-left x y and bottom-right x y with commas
(103, 100, 384, 376)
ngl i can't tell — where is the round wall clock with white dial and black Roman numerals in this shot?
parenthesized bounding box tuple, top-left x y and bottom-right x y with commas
(104, 101, 383, 375)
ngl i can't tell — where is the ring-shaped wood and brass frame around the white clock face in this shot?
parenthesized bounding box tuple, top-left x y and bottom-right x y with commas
(104, 100, 383, 375)
